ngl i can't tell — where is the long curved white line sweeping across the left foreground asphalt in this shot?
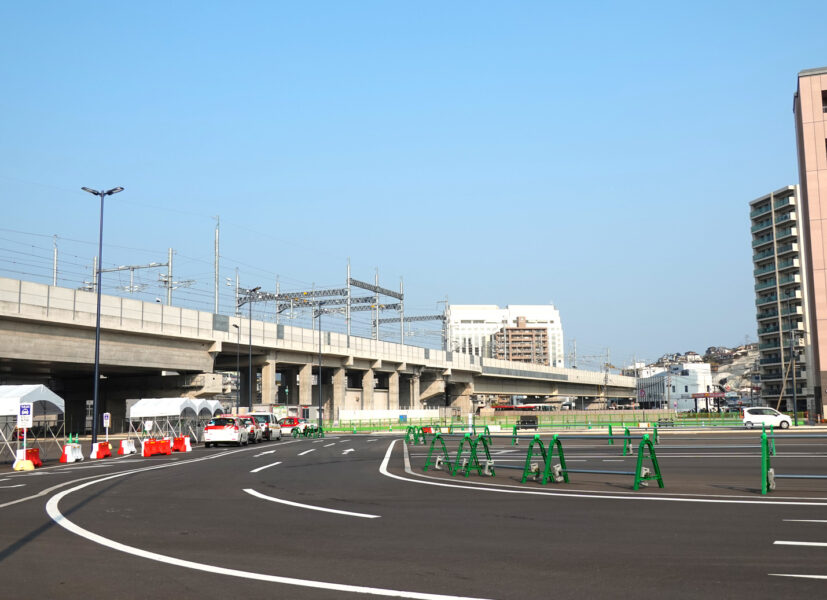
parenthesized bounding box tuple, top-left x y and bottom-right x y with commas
(46, 446, 489, 600)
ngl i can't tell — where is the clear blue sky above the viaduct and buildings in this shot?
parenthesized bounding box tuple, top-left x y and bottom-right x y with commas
(0, 1, 827, 370)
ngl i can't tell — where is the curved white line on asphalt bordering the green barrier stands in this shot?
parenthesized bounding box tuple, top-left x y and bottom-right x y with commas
(379, 440, 827, 506)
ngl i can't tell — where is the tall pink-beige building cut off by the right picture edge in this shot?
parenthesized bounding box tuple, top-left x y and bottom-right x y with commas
(793, 67, 827, 416)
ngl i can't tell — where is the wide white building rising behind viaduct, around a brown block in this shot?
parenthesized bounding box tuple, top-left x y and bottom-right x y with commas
(447, 304, 565, 367)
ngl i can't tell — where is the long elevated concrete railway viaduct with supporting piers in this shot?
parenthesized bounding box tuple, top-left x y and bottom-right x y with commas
(0, 278, 635, 430)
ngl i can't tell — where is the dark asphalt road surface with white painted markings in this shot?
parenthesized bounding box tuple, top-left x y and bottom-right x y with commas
(0, 432, 827, 600)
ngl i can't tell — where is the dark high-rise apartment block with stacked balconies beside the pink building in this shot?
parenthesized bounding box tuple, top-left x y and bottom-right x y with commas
(749, 185, 813, 410)
